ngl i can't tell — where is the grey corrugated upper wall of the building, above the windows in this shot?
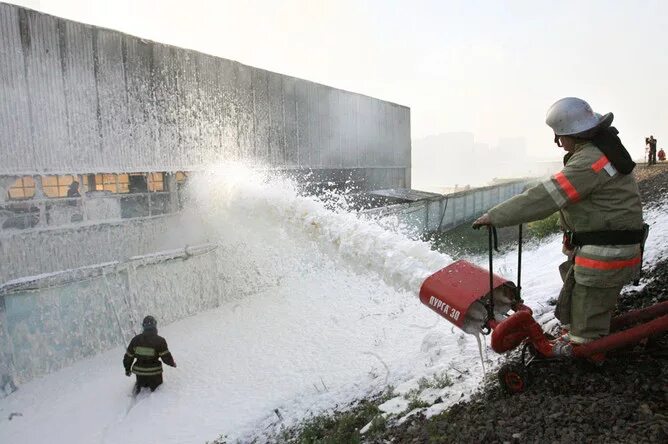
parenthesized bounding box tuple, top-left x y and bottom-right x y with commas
(0, 4, 411, 188)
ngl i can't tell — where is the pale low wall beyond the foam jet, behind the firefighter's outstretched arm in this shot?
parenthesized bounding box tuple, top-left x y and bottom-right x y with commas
(364, 180, 535, 234)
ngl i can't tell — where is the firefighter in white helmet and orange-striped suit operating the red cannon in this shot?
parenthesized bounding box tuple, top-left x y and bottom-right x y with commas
(473, 97, 646, 345)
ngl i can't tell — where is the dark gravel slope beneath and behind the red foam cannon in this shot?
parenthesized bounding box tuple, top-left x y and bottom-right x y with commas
(370, 165, 668, 443)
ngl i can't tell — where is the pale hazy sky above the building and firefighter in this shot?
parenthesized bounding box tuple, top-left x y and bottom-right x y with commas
(12, 0, 668, 158)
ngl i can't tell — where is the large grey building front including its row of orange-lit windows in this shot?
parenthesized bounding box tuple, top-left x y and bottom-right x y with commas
(0, 3, 411, 283)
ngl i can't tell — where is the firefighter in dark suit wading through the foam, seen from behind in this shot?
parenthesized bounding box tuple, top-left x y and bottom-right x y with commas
(123, 316, 176, 394)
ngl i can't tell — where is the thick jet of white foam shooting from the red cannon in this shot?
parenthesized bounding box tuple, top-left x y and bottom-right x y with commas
(185, 164, 452, 293)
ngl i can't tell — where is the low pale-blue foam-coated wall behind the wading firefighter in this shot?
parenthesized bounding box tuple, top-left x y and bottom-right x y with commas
(0, 245, 231, 383)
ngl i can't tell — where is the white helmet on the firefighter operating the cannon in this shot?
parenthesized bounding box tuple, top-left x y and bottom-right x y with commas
(545, 97, 613, 136)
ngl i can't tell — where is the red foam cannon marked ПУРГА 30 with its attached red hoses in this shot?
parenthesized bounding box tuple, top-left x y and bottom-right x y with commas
(420, 260, 668, 358)
